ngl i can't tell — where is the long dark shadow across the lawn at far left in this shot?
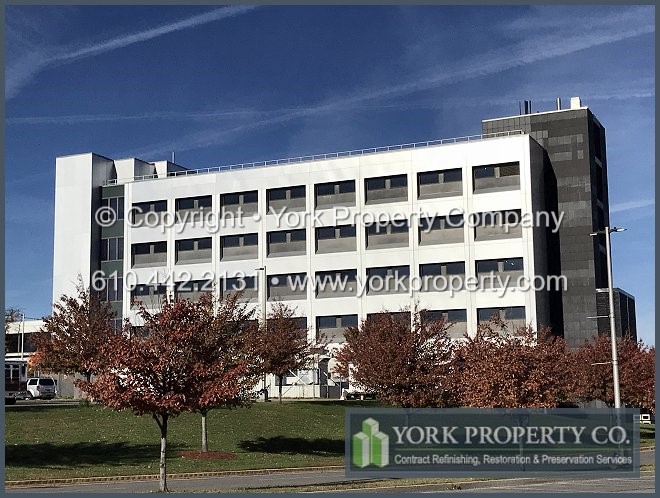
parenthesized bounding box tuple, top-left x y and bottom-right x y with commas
(5, 442, 180, 468)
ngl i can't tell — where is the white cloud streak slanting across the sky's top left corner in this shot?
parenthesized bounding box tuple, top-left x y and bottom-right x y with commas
(5, 5, 257, 99)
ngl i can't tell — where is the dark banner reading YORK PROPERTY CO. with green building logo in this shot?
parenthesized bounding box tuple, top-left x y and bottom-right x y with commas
(346, 408, 639, 477)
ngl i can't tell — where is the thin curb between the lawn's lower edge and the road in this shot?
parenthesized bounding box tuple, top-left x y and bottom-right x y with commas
(5, 465, 344, 488)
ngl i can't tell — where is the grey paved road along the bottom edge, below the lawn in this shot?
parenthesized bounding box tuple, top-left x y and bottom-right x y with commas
(6, 451, 655, 493)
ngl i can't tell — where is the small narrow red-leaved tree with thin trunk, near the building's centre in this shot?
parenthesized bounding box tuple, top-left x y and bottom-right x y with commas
(250, 302, 323, 403)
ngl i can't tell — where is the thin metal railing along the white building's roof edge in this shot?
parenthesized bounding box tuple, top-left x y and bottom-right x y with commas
(103, 130, 524, 185)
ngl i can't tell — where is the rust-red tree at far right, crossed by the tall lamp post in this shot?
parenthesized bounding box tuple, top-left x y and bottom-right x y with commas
(575, 335, 655, 413)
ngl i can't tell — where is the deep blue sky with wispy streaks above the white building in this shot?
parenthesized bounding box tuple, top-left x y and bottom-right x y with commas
(5, 6, 655, 344)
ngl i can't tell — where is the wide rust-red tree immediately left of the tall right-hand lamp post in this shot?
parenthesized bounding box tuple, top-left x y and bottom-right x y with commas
(454, 318, 575, 408)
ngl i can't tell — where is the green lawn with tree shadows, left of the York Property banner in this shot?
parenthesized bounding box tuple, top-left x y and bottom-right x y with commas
(5, 401, 378, 480)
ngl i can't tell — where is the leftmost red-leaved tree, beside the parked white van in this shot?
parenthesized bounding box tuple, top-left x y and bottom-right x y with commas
(30, 278, 117, 392)
